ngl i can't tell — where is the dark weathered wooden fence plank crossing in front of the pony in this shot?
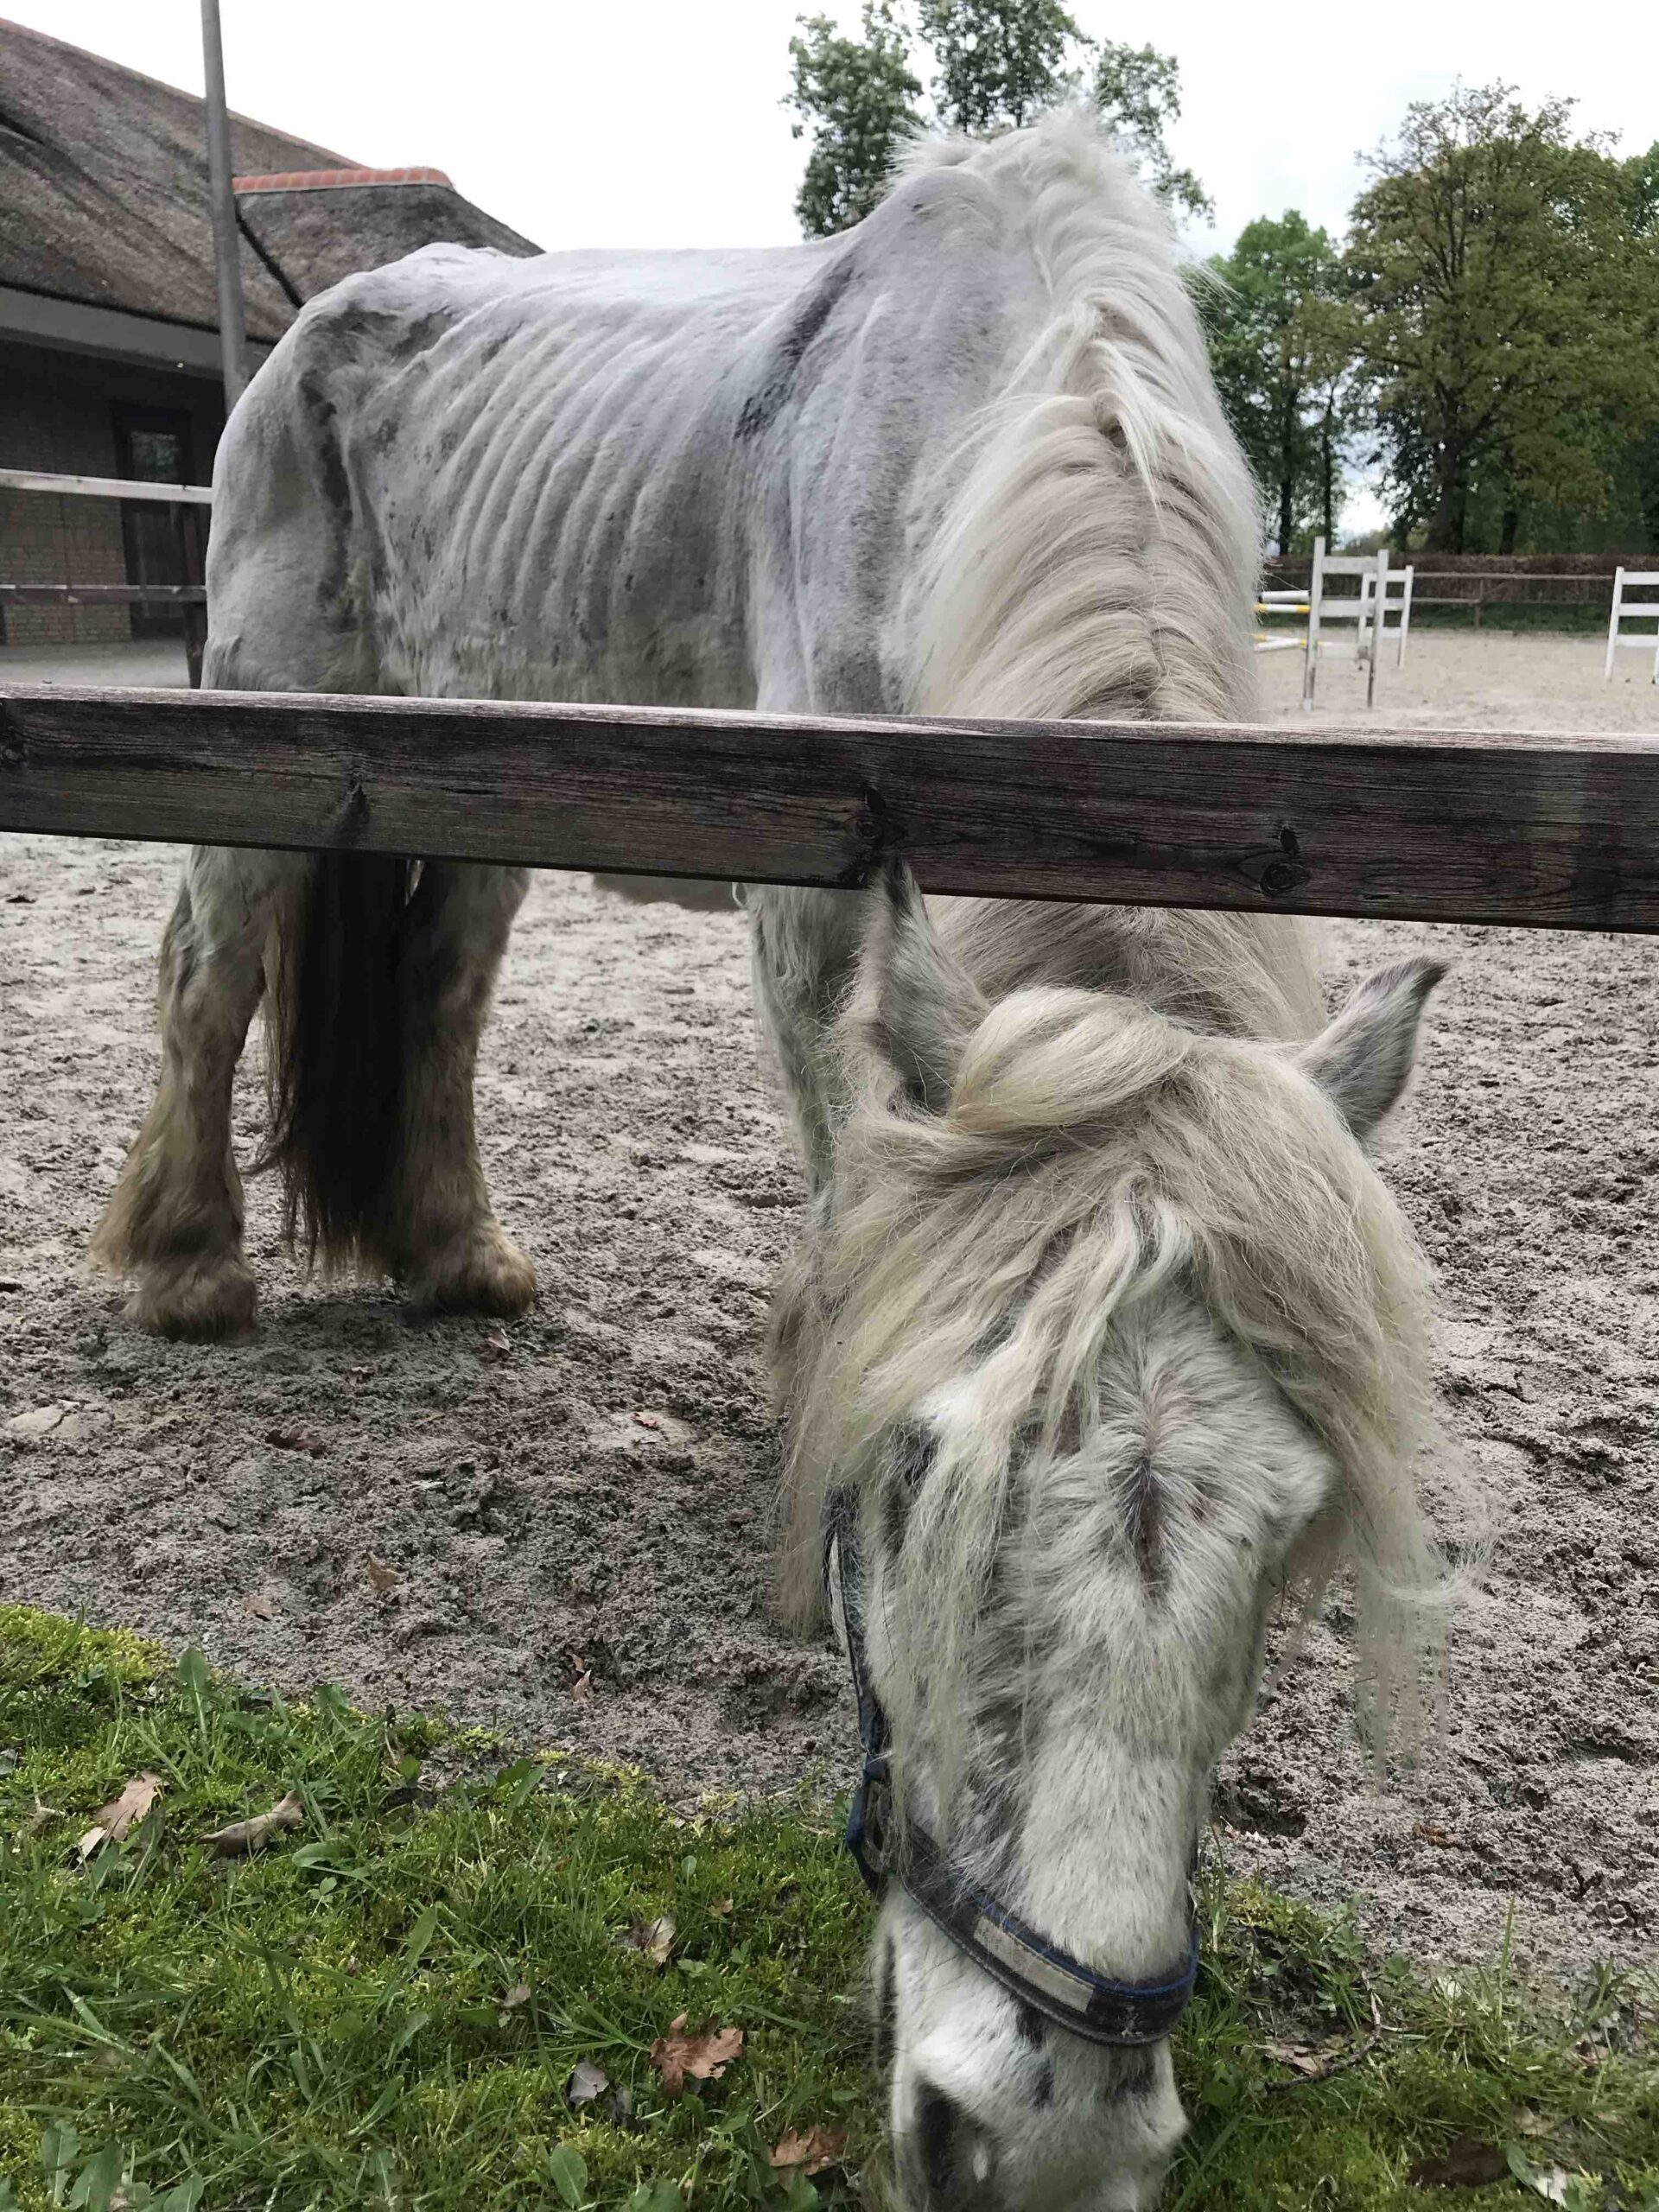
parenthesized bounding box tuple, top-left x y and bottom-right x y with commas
(0, 686, 1659, 929)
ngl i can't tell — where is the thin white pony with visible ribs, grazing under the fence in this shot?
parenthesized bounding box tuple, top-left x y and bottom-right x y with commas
(99, 118, 1438, 2212)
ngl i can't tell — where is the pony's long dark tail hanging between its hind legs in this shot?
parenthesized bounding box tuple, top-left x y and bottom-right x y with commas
(259, 854, 418, 1272)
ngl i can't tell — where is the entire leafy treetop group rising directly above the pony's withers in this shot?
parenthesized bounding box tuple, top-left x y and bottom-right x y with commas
(785, 0, 1210, 237)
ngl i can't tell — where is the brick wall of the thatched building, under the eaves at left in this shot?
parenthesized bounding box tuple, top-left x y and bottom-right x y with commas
(0, 343, 224, 646)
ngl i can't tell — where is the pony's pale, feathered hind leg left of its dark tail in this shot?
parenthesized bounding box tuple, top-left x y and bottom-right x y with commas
(93, 845, 305, 1336)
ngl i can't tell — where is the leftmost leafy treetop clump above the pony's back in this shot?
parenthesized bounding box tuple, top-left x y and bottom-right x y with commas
(785, 0, 923, 238)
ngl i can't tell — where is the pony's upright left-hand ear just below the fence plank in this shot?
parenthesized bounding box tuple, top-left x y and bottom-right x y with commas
(852, 858, 984, 1113)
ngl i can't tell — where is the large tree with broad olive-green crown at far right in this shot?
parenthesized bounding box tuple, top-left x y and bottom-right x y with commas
(1347, 84, 1659, 550)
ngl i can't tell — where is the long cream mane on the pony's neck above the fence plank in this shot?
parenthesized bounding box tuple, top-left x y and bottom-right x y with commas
(905, 111, 1256, 719)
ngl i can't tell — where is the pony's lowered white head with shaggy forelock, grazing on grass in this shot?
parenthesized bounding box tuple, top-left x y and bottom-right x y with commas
(777, 869, 1442, 2212)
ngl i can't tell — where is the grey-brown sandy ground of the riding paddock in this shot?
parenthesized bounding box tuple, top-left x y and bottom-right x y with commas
(0, 632, 1659, 1960)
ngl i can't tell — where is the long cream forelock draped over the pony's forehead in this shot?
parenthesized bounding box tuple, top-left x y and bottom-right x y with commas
(779, 988, 1445, 1738)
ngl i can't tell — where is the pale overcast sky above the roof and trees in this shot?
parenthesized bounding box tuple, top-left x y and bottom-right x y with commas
(13, 0, 1659, 248)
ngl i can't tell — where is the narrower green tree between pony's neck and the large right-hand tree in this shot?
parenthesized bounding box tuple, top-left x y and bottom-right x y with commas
(1201, 208, 1351, 553)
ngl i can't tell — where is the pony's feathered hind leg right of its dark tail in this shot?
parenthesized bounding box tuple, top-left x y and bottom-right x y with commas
(387, 861, 536, 1314)
